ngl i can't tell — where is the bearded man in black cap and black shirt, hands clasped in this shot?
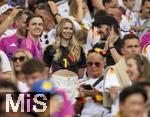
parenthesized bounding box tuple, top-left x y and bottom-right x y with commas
(94, 16, 121, 66)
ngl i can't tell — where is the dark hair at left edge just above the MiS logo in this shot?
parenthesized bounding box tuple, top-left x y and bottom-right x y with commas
(0, 79, 19, 92)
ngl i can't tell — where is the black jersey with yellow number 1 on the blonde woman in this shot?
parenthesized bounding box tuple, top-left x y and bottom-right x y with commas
(44, 45, 86, 73)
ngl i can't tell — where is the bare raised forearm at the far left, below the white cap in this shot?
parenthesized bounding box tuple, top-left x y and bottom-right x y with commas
(0, 7, 21, 35)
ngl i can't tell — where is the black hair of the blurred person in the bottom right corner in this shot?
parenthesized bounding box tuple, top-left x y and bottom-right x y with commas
(119, 85, 148, 103)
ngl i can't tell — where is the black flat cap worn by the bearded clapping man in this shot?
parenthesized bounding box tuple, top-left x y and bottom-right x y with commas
(93, 15, 119, 27)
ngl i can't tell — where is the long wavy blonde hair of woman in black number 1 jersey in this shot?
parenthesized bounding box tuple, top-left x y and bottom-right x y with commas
(53, 18, 81, 60)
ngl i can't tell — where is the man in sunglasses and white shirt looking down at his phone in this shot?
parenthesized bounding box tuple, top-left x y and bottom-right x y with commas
(75, 49, 109, 117)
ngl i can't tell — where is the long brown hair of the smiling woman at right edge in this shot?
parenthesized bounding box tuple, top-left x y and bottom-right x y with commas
(128, 55, 150, 81)
